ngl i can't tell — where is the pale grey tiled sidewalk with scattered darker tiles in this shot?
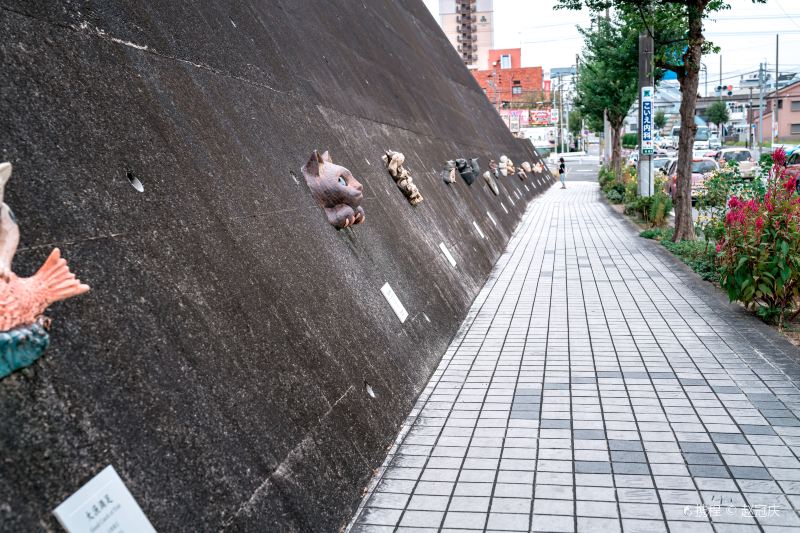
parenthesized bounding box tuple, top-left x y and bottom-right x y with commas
(351, 183, 800, 533)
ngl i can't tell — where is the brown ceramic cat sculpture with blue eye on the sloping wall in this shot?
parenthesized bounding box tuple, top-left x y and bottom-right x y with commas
(302, 150, 365, 229)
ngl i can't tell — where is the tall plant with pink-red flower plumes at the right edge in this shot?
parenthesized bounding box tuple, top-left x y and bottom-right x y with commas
(717, 149, 800, 328)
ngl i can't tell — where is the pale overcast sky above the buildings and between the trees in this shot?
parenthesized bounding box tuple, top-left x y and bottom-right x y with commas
(424, 0, 800, 94)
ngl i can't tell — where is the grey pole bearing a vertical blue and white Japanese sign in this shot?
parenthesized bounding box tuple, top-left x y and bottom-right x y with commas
(637, 32, 655, 196)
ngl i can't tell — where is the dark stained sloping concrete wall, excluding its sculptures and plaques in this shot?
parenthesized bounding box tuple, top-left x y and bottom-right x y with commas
(0, 0, 552, 532)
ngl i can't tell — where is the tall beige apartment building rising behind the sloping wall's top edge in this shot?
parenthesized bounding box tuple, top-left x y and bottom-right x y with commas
(439, 0, 494, 68)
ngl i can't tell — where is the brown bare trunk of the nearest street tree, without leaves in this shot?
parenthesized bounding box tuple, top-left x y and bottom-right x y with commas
(673, 0, 706, 242)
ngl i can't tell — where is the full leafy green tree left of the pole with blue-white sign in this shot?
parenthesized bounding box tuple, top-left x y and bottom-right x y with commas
(575, 15, 638, 181)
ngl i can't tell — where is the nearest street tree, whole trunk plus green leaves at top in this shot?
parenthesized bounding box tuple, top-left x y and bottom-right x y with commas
(555, 0, 766, 241)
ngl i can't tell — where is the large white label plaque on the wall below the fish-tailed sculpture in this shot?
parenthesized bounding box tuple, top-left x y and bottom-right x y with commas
(53, 465, 156, 533)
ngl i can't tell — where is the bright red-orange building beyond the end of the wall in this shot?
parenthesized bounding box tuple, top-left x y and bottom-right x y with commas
(472, 48, 545, 108)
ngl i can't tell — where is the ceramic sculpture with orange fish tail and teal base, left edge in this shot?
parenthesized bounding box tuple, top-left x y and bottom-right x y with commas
(0, 163, 89, 378)
